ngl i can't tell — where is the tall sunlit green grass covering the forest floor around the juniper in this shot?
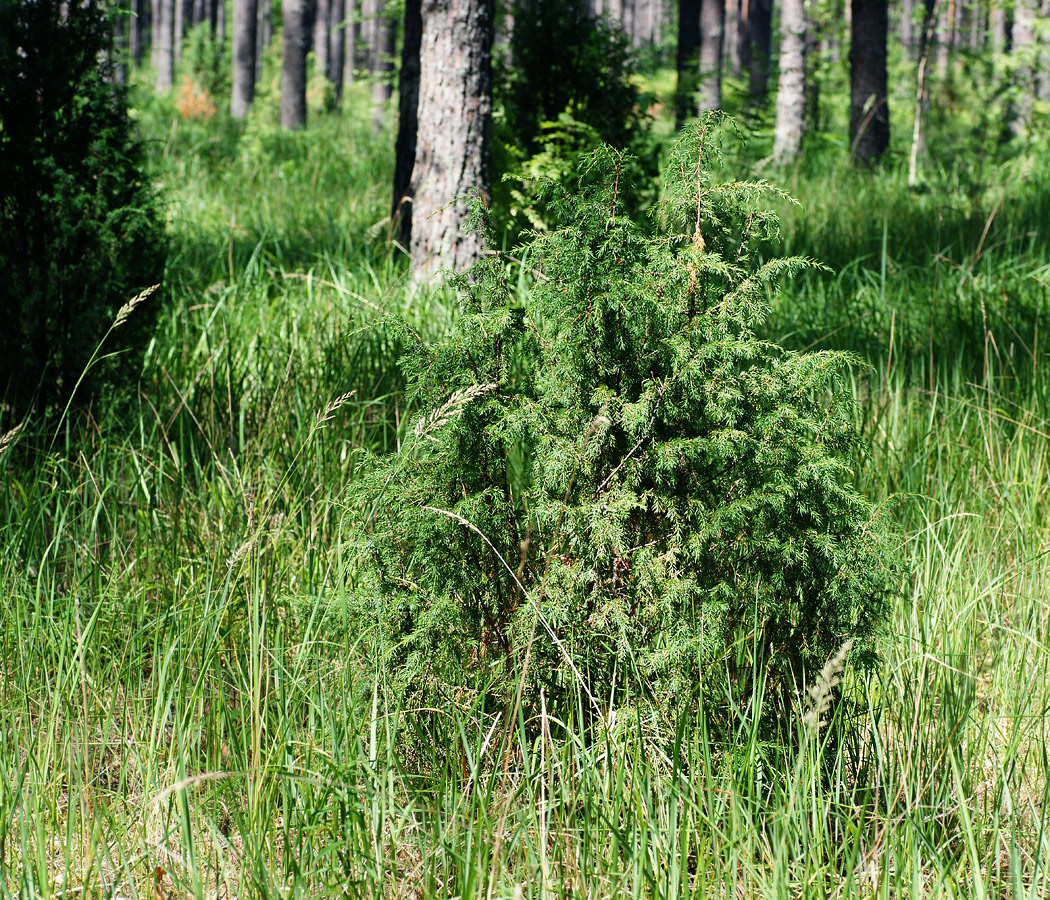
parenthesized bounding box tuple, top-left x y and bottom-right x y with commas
(0, 87, 1050, 900)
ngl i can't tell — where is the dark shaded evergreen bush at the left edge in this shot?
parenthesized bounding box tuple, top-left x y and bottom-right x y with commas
(0, 0, 164, 418)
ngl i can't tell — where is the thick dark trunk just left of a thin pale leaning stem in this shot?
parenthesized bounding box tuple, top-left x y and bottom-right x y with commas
(849, 0, 889, 165)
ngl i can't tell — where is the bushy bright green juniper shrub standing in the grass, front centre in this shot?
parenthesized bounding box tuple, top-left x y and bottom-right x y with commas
(346, 118, 901, 751)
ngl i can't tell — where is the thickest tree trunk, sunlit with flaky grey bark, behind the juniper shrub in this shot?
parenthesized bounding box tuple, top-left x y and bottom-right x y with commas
(412, 0, 495, 279)
